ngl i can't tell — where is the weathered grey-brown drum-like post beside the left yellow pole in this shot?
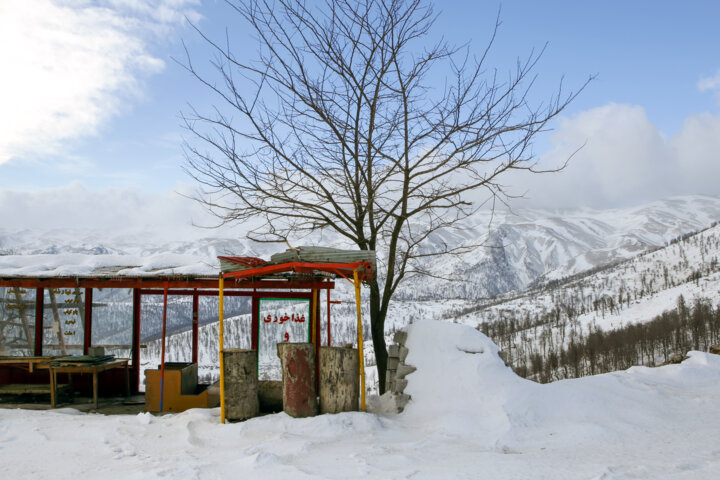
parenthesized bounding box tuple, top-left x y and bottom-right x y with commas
(223, 348, 260, 420)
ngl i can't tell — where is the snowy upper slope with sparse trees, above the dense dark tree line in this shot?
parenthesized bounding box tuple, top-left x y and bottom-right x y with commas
(460, 221, 720, 331)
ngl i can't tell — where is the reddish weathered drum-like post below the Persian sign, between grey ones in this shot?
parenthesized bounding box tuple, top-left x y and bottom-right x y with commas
(277, 343, 317, 418)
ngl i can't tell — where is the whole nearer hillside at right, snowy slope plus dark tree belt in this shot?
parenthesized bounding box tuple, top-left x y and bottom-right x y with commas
(456, 221, 720, 381)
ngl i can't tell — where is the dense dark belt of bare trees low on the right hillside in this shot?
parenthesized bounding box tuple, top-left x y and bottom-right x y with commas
(477, 295, 720, 383)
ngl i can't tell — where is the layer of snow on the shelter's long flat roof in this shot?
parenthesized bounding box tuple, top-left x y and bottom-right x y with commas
(0, 253, 220, 278)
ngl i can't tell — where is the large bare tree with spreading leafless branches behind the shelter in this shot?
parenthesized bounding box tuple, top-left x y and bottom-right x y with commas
(184, 0, 592, 392)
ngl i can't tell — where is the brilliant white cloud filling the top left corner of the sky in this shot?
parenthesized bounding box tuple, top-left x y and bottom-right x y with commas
(0, 0, 197, 163)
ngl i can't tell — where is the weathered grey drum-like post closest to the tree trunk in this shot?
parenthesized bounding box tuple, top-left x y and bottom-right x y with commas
(320, 347, 360, 413)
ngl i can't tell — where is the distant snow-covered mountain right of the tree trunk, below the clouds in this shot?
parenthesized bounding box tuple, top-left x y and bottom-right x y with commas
(401, 196, 720, 299)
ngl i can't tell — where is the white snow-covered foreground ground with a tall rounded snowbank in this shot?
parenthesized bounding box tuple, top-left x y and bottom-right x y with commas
(0, 320, 720, 480)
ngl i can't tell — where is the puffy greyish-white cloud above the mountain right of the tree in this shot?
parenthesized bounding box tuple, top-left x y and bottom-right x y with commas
(508, 104, 720, 208)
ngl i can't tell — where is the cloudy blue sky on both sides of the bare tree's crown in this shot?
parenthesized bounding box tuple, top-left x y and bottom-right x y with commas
(0, 0, 720, 218)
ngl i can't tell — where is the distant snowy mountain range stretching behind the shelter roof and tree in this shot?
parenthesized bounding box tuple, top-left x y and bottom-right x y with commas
(0, 196, 720, 300)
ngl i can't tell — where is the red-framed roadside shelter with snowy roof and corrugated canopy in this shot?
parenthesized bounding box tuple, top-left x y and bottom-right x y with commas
(0, 248, 375, 408)
